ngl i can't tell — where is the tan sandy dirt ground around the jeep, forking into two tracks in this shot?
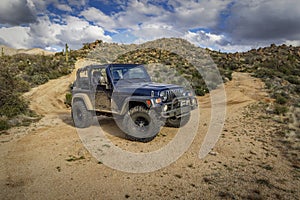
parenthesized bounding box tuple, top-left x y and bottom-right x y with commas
(0, 60, 300, 199)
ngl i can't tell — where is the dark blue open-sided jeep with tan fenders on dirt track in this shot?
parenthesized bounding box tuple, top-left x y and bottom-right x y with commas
(72, 64, 197, 141)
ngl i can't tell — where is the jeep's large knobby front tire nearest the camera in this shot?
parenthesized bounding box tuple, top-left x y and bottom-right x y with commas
(122, 106, 162, 142)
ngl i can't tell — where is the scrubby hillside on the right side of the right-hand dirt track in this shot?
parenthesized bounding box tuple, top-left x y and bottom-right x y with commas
(210, 44, 300, 169)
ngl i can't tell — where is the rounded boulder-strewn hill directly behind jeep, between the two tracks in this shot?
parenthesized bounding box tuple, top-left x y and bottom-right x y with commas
(86, 38, 232, 95)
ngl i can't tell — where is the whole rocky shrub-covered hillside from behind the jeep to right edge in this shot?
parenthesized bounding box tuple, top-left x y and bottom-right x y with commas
(85, 38, 300, 162)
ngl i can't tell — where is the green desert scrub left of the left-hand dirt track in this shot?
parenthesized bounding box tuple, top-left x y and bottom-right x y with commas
(0, 50, 76, 130)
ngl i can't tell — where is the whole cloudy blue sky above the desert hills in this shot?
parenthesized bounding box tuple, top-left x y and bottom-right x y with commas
(0, 0, 300, 52)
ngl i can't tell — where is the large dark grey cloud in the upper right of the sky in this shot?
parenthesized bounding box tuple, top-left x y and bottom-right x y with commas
(226, 0, 300, 44)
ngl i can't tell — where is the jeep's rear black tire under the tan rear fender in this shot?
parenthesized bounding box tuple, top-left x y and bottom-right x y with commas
(72, 101, 93, 128)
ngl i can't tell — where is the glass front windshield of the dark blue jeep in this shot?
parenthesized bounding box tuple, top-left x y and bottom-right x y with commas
(110, 64, 151, 84)
